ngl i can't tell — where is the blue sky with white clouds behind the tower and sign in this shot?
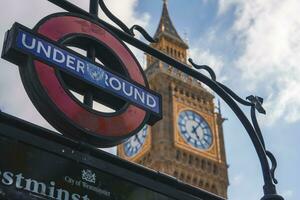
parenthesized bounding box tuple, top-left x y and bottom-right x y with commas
(0, 0, 300, 200)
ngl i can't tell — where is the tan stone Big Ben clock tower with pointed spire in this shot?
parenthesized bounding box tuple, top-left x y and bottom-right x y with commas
(118, 0, 228, 198)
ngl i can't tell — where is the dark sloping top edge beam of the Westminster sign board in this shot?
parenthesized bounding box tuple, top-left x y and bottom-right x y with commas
(0, 111, 225, 200)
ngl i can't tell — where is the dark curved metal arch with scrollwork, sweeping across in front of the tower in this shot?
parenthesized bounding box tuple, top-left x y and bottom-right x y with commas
(24, 0, 283, 200)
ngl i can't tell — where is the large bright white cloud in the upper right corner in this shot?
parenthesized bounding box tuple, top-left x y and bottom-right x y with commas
(220, 0, 300, 123)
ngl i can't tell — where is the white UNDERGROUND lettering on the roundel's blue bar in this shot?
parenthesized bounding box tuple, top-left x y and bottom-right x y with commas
(19, 33, 159, 113)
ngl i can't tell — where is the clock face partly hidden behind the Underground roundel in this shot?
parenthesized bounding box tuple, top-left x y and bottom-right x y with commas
(123, 125, 148, 157)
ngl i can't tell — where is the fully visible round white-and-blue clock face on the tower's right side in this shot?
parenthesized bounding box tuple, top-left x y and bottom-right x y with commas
(178, 110, 212, 150)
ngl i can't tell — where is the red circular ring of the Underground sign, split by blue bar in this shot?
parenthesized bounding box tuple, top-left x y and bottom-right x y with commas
(34, 16, 146, 137)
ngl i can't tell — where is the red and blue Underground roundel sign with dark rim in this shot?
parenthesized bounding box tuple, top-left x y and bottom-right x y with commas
(2, 13, 162, 147)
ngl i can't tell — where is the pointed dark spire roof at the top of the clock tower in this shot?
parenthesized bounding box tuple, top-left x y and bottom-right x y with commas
(154, 0, 188, 48)
